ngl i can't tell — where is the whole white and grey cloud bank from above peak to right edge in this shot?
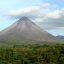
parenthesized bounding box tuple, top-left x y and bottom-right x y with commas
(8, 3, 64, 30)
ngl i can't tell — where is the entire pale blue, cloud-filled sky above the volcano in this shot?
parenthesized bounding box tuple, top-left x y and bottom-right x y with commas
(0, 0, 64, 36)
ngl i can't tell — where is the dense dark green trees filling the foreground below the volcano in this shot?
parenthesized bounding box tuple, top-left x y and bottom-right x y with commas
(0, 44, 64, 64)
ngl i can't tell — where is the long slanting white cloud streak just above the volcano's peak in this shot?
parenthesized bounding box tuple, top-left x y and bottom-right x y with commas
(8, 3, 50, 17)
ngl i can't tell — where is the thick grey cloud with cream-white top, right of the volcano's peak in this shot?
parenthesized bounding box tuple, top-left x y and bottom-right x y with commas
(35, 8, 64, 30)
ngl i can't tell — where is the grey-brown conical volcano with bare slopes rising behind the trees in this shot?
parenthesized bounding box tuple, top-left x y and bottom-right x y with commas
(0, 17, 57, 42)
